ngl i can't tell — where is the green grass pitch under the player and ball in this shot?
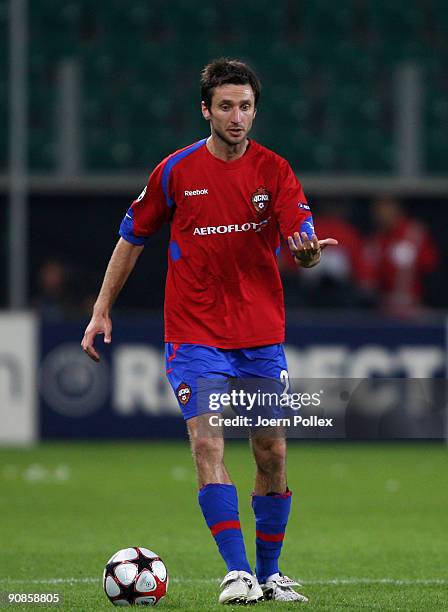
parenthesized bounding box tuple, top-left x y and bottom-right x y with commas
(0, 442, 448, 612)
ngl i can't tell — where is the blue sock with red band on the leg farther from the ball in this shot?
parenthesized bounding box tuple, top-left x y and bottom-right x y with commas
(252, 489, 291, 584)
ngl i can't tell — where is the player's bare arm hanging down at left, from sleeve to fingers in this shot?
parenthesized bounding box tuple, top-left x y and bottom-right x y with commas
(81, 238, 144, 362)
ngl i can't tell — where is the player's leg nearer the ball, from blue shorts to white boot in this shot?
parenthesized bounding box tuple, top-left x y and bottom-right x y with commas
(166, 344, 263, 603)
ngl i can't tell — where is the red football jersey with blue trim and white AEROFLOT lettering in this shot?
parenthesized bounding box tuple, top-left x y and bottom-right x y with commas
(120, 139, 313, 349)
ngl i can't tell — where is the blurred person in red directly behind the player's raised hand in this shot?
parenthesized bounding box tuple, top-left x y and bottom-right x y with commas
(279, 200, 372, 309)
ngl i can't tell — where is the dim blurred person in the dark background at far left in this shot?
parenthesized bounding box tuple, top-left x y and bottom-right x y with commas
(32, 259, 73, 319)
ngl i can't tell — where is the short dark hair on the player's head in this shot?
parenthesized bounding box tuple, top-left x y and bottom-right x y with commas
(201, 57, 261, 108)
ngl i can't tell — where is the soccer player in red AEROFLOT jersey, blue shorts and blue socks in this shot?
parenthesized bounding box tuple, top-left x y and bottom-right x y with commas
(82, 59, 337, 604)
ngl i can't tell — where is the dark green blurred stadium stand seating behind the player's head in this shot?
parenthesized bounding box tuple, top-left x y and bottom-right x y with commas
(0, 0, 448, 173)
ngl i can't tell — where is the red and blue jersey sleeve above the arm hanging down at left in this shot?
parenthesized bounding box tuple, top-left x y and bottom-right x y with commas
(119, 160, 173, 246)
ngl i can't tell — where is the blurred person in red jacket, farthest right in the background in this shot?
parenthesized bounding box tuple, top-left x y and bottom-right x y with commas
(362, 196, 439, 316)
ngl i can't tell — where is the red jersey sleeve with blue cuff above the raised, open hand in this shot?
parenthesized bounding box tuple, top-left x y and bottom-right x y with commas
(274, 160, 314, 240)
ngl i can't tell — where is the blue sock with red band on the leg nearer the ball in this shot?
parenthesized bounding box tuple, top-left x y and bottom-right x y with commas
(198, 484, 252, 574)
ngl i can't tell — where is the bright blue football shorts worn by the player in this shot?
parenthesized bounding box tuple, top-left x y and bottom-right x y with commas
(165, 342, 288, 420)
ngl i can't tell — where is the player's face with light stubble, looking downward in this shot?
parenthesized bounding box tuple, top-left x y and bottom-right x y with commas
(202, 84, 257, 146)
